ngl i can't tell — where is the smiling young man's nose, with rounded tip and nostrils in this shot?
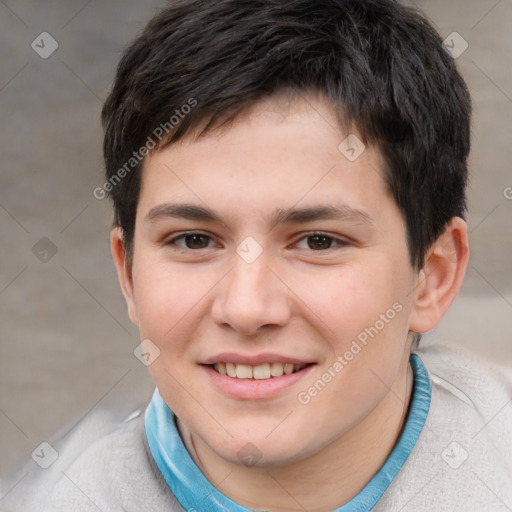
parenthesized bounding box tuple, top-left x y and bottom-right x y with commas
(212, 247, 291, 336)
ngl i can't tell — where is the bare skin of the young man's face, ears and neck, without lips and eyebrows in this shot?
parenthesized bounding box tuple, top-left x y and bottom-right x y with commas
(111, 95, 468, 511)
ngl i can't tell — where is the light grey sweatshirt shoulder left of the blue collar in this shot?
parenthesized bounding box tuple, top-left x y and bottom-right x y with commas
(0, 410, 182, 512)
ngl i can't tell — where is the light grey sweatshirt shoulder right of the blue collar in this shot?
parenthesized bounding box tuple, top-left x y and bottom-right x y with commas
(375, 342, 512, 512)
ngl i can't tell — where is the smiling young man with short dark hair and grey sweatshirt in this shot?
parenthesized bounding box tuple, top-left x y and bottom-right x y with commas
(5, 0, 512, 512)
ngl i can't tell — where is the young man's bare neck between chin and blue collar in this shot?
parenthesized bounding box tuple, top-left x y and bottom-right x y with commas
(178, 359, 413, 512)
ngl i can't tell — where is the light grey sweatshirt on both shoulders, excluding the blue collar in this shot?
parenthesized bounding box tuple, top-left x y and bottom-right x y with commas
(0, 345, 512, 512)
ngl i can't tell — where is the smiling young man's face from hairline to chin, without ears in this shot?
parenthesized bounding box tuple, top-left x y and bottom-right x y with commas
(119, 96, 416, 466)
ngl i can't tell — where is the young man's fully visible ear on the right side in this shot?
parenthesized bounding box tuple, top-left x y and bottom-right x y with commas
(409, 217, 469, 333)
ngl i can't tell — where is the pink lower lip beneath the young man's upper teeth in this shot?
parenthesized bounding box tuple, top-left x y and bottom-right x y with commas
(203, 364, 315, 400)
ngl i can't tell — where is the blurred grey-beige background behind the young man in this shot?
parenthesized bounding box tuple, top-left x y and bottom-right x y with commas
(0, 0, 512, 496)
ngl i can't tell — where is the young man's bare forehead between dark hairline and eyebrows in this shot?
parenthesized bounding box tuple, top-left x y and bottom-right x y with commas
(135, 95, 391, 230)
